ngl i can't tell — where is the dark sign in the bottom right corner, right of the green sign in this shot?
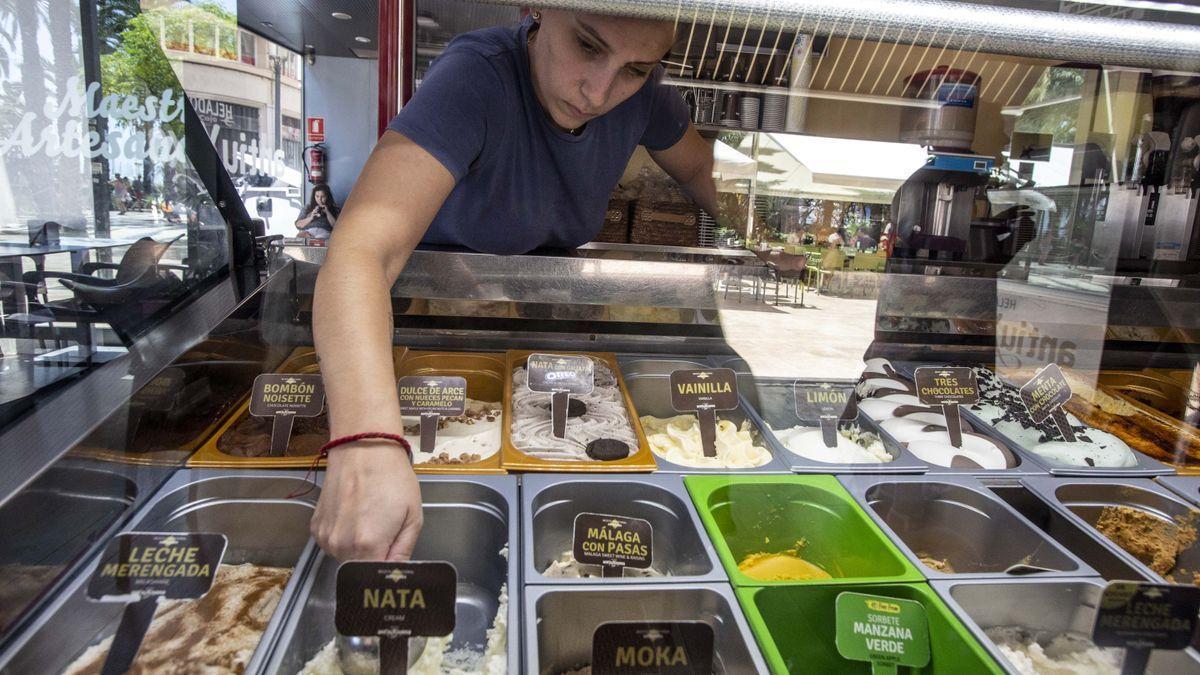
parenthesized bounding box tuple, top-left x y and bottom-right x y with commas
(1092, 581, 1200, 673)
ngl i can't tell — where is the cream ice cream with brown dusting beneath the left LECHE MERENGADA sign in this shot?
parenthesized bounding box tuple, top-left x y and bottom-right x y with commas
(64, 565, 292, 675)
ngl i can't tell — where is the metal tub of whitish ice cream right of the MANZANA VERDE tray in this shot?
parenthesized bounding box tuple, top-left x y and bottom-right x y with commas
(931, 579, 1200, 675)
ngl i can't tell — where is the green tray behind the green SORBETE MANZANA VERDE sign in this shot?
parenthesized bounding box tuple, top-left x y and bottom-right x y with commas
(736, 584, 1004, 675)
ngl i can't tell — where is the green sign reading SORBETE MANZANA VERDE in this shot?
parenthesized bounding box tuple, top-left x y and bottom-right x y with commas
(835, 592, 929, 674)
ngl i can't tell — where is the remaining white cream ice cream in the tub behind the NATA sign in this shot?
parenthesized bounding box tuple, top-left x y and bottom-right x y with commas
(300, 585, 509, 675)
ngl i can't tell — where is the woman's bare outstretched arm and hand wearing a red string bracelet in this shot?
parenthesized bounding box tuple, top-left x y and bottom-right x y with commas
(312, 131, 455, 561)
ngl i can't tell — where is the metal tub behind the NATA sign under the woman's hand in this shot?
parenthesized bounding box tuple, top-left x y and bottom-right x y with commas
(265, 476, 521, 675)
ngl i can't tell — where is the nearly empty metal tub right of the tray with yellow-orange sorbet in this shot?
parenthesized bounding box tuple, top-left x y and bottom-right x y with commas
(839, 476, 1096, 579)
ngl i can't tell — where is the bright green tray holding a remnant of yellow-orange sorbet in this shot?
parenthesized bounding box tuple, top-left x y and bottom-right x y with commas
(685, 476, 925, 586)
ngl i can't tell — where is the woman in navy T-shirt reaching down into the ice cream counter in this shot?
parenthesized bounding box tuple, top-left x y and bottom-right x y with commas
(312, 11, 716, 560)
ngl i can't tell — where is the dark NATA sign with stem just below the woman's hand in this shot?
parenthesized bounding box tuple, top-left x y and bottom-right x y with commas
(334, 561, 458, 674)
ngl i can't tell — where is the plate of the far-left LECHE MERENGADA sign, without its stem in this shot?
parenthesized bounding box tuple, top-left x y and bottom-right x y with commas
(88, 532, 227, 602)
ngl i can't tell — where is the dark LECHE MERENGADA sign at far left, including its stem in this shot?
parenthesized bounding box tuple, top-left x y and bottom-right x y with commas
(88, 532, 228, 674)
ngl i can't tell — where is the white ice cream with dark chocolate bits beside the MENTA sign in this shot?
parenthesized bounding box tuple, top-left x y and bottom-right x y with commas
(968, 368, 1138, 467)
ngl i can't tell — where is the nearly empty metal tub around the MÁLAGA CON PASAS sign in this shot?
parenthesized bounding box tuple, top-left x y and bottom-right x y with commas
(521, 473, 727, 585)
